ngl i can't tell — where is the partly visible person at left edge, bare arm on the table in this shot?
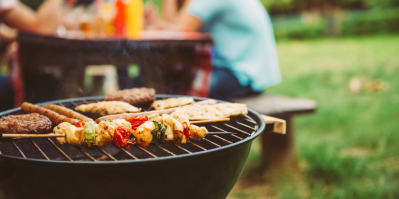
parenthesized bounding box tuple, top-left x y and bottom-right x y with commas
(0, 0, 67, 111)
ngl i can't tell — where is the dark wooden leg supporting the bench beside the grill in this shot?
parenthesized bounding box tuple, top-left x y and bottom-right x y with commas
(260, 114, 294, 171)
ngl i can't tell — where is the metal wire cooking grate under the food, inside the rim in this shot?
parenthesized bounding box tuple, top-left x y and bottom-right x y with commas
(0, 97, 259, 162)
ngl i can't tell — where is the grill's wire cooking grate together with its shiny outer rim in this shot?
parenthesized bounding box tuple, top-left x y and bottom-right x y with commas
(0, 95, 266, 164)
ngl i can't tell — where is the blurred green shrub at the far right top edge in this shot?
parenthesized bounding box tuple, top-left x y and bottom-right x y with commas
(342, 8, 399, 36)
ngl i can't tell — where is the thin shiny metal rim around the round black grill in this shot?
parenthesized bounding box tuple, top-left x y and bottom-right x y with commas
(0, 94, 266, 167)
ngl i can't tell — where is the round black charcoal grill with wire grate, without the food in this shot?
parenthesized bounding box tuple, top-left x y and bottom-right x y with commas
(0, 95, 265, 199)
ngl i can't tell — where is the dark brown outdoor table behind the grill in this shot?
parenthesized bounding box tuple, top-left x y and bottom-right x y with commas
(18, 32, 212, 102)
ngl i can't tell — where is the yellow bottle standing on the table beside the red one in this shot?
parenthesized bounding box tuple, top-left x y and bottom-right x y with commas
(126, 0, 144, 39)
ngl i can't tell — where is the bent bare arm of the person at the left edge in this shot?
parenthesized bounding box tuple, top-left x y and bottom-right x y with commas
(0, 0, 63, 34)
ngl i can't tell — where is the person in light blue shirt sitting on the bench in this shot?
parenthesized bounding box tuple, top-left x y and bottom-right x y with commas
(146, 0, 282, 101)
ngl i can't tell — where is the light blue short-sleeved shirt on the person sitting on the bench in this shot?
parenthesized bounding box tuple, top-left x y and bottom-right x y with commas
(188, 0, 281, 91)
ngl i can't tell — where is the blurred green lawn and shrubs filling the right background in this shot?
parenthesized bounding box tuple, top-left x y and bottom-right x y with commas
(18, 0, 399, 199)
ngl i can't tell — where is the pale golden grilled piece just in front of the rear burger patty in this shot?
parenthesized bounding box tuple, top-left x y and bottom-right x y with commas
(75, 101, 141, 116)
